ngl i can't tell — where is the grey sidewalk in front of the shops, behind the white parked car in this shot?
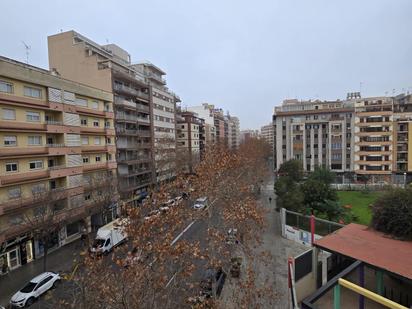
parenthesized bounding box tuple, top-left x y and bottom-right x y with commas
(0, 239, 81, 306)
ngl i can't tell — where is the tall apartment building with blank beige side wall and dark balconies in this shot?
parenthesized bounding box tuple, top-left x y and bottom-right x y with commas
(48, 31, 156, 204)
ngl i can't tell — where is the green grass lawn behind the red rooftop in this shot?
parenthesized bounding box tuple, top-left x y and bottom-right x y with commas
(338, 191, 381, 225)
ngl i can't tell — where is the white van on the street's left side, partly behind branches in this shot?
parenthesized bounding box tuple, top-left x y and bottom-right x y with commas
(90, 219, 127, 254)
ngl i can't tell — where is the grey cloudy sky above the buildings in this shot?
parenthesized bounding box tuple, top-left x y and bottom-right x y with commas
(0, 0, 412, 129)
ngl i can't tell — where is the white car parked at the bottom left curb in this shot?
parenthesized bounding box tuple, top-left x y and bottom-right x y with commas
(10, 272, 61, 308)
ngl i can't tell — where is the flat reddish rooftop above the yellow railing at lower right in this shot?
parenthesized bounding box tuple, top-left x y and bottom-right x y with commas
(315, 223, 412, 279)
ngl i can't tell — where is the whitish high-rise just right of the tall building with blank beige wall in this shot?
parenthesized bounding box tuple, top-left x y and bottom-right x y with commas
(132, 61, 180, 181)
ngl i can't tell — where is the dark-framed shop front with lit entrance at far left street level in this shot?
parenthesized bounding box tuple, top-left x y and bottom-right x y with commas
(0, 234, 34, 275)
